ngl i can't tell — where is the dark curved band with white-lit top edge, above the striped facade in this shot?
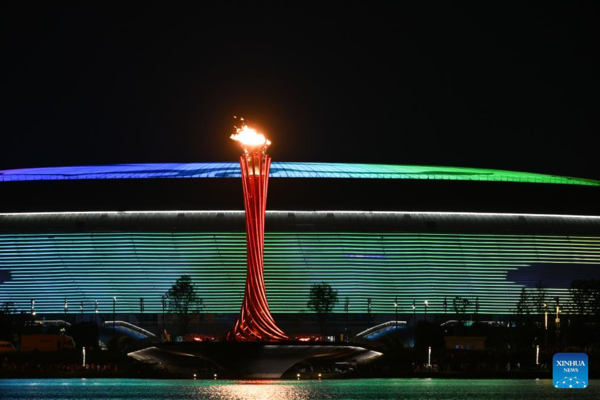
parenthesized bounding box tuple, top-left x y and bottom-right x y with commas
(0, 210, 600, 236)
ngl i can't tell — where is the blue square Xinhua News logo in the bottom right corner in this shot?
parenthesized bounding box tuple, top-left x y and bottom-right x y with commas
(552, 353, 588, 389)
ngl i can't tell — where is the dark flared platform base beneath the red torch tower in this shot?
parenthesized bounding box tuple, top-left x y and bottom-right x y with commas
(128, 342, 381, 379)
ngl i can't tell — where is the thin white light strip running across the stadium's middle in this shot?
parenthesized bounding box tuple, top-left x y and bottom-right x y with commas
(0, 210, 600, 220)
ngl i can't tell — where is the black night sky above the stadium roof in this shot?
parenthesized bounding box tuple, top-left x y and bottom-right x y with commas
(0, 2, 600, 179)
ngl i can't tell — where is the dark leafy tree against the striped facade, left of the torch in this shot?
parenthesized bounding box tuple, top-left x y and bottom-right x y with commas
(167, 275, 204, 333)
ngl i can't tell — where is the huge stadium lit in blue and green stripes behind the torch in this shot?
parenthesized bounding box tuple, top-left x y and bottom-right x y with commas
(0, 162, 600, 332)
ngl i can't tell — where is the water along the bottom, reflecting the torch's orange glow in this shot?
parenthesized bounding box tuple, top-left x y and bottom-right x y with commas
(0, 379, 600, 400)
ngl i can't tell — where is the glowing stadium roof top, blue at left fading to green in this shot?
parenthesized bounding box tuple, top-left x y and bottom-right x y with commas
(0, 162, 600, 186)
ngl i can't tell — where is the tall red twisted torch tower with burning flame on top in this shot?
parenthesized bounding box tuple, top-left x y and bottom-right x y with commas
(227, 125, 288, 341)
